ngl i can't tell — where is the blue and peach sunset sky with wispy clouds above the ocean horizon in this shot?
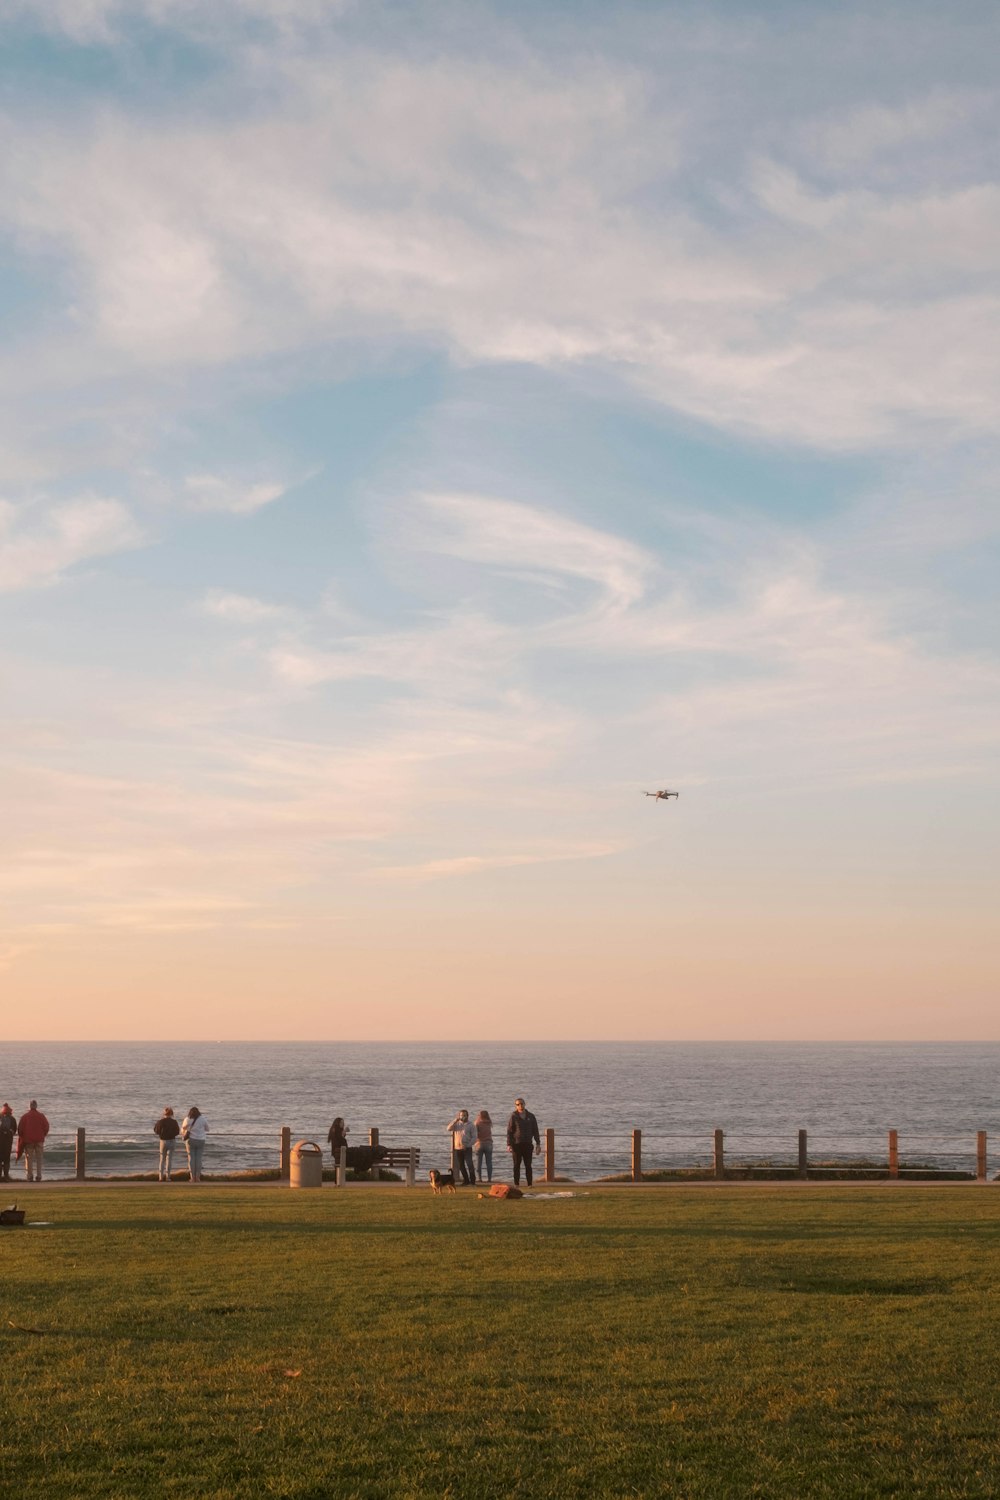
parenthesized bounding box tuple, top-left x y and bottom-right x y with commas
(0, 0, 1000, 1041)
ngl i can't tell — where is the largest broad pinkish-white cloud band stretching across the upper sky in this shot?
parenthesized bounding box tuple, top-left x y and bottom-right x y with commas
(3, 12, 1000, 447)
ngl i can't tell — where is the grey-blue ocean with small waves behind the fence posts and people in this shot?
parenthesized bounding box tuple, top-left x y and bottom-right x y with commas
(0, 1041, 1000, 1179)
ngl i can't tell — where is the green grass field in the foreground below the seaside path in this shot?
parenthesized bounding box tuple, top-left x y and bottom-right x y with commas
(0, 1185, 1000, 1500)
